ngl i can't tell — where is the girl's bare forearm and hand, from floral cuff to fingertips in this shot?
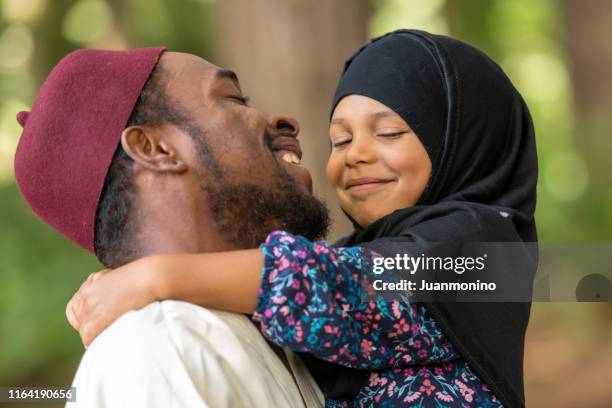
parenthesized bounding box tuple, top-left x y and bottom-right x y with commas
(66, 249, 263, 347)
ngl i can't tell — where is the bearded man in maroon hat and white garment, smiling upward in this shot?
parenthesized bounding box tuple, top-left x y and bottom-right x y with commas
(15, 48, 328, 407)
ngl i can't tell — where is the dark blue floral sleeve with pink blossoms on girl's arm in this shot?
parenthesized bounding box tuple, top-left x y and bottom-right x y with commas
(253, 231, 459, 369)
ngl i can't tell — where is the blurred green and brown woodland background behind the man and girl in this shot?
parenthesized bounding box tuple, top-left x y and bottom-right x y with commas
(0, 0, 612, 407)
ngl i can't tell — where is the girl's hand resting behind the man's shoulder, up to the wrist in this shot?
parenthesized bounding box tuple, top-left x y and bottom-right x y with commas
(66, 257, 157, 348)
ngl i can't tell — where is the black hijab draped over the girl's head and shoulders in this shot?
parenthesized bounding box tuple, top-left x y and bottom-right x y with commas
(305, 30, 537, 407)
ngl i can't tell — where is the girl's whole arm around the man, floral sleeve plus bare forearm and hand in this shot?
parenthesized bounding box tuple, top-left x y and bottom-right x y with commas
(67, 232, 457, 368)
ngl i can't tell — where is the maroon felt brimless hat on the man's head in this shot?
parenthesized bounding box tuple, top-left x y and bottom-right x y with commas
(15, 48, 165, 253)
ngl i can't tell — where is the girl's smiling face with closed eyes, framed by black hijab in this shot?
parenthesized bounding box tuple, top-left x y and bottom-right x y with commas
(327, 95, 431, 228)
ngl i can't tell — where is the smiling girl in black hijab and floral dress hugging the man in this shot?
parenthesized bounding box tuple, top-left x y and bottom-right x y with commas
(71, 30, 537, 407)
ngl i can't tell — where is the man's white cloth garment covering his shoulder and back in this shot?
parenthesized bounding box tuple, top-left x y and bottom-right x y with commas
(66, 300, 323, 408)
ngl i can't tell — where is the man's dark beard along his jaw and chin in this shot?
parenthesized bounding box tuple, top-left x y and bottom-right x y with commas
(198, 139, 330, 249)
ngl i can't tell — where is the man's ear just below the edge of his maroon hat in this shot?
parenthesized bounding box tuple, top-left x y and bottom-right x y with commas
(121, 126, 187, 173)
